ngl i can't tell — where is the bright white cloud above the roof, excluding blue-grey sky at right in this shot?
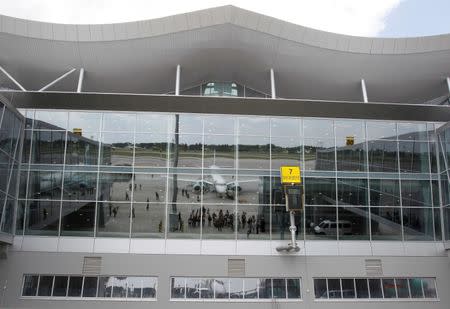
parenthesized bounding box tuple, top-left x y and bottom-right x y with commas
(0, 0, 403, 36)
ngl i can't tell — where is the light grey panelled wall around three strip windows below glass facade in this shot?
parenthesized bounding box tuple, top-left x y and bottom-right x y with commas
(0, 251, 450, 309)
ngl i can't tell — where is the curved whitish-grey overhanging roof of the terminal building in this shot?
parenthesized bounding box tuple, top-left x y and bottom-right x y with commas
(0, 6, 450, 103)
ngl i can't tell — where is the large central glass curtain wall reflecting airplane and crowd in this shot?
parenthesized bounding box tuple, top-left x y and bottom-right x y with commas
(17, 110, 443, 241)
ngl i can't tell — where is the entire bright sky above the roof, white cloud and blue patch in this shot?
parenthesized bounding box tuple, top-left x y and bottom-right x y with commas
(0, 0, 450, 37)
